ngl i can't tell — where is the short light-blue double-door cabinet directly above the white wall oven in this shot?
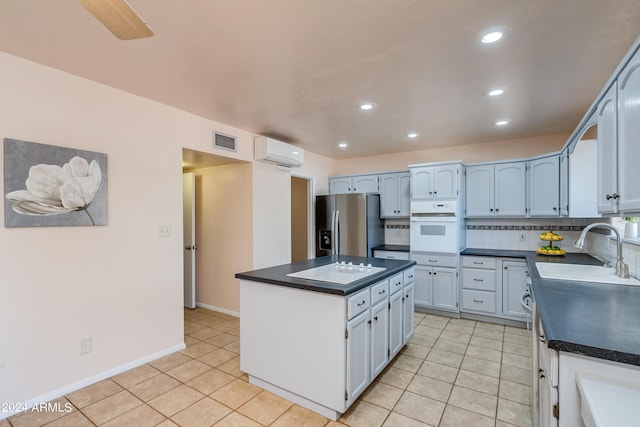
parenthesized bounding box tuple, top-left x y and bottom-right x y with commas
(409, 163, 462, 200)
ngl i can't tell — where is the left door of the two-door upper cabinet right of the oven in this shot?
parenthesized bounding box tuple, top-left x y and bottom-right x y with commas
(465, 165, 494, 217)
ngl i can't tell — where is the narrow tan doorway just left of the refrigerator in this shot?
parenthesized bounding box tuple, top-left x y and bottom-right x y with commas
(291, 175, 313, 262)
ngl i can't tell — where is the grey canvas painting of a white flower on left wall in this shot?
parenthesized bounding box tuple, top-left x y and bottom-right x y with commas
(4, 138, 108, 227)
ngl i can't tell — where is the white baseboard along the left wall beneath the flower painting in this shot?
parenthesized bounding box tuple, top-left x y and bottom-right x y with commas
(0, 343, 186, 420)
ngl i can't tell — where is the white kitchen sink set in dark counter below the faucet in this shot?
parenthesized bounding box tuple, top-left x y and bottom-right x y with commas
(536, 262, 640, 286)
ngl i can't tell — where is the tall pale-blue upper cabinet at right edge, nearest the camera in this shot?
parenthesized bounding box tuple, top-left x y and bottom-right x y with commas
(596, 47, 640, 214)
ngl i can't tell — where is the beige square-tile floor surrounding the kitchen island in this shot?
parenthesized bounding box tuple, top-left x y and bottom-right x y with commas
(6, 308, 532, 427)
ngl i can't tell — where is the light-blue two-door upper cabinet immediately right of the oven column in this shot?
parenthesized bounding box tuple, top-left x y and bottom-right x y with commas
(465, 162, 526, 217)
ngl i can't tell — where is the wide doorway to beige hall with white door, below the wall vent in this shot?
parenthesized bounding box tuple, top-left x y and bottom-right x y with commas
(181, 149, 253, 315)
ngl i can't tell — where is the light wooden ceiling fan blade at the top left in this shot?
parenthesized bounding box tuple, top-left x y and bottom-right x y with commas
(78, 0, 153, 40)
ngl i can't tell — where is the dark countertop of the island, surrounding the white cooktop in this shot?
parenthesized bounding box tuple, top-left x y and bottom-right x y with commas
(235, 255, 416, 295)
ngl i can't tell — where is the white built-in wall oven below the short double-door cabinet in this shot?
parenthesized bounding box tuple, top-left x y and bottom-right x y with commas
(409, 200, 464, 253)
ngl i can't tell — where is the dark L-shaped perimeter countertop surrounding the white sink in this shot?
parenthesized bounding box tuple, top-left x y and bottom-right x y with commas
(461, 248, 640, 366)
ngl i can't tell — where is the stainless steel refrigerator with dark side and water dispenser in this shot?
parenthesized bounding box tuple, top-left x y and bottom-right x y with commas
(316, 193, 384, 257)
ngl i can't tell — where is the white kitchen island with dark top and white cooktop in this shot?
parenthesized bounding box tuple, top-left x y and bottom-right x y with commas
(236, 256, 415, 420)
